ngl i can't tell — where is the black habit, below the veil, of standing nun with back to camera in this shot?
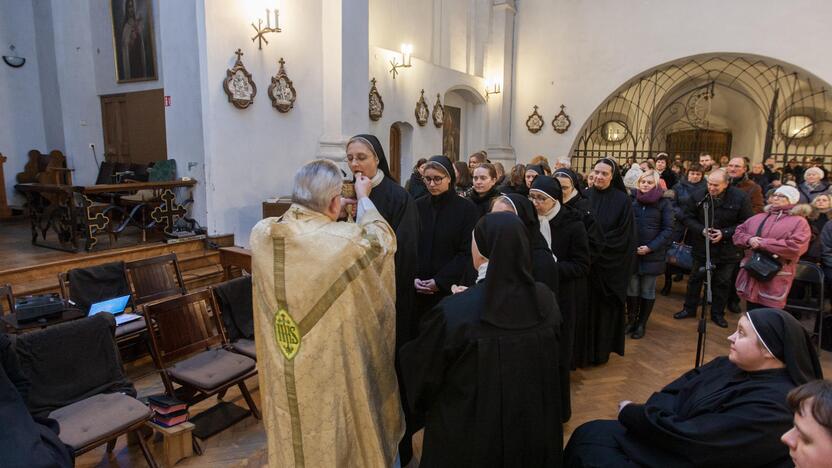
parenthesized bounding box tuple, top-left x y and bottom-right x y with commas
(401, 283, 563, 467)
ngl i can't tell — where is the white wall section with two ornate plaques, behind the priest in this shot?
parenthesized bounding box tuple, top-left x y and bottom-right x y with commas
(194, 0, 324, 245)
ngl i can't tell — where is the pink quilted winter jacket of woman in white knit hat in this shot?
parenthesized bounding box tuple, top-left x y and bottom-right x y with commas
(733, 205, 812, 309)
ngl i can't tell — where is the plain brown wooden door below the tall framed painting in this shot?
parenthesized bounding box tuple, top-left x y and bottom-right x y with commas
(101, 89, 167, 164)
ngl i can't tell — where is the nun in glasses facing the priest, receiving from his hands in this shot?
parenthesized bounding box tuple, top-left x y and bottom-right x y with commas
(347, 135, 419, 464)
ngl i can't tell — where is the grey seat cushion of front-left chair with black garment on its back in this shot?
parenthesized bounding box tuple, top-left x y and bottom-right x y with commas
(49, 393, 151, 450)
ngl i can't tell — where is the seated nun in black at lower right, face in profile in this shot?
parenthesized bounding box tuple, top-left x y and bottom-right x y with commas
(564, 309, 823, 468)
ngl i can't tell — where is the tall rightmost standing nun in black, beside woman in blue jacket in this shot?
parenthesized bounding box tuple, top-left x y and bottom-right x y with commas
(575, 158, 636, 367)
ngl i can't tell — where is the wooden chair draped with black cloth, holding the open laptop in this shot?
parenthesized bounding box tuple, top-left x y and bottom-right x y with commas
(58, 262, 147, 345)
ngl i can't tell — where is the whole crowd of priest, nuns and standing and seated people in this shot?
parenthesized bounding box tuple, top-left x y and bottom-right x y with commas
(251, 143, 832, 466)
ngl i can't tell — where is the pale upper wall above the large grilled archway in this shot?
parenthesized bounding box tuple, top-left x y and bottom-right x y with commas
(511, 0, 832, 166)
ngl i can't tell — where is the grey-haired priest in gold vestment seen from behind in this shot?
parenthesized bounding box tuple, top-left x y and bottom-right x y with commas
(251, 160, 404, 466)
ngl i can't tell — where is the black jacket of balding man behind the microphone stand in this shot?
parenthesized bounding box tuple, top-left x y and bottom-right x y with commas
(683, 187, 754, 264)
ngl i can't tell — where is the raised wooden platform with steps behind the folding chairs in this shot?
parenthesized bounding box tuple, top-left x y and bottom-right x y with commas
(0, 220, 229, 296)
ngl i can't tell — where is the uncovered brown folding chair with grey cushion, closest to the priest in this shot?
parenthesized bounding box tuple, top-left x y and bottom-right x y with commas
(145, 290, 260, 419)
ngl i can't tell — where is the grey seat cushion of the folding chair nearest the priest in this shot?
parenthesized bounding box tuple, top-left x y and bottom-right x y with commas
(168, 349, 256, 391)
